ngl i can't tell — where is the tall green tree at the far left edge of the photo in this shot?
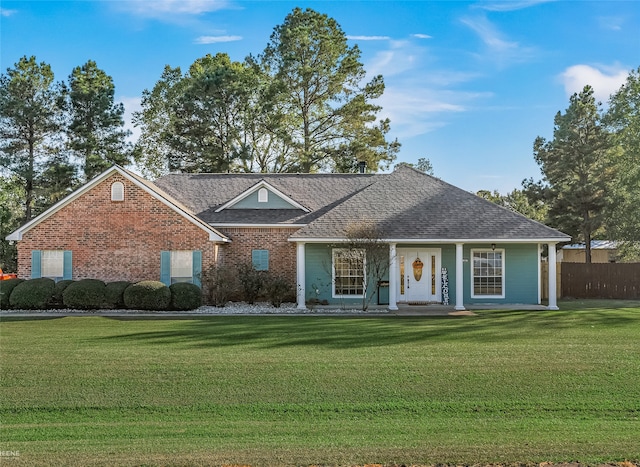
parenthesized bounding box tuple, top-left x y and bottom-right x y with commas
(0, 56, 62, 222)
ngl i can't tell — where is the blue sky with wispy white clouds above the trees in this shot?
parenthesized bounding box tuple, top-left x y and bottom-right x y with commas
(0, 0, 640, 193)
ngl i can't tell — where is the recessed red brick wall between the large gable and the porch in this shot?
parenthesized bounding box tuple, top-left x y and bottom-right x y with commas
(217, 227, 299, 285)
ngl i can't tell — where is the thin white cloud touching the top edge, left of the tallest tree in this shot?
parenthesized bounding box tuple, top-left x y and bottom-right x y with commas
(116, 0, 230, 18)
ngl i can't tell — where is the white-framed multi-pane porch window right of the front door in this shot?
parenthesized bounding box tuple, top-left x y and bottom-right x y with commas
(471, 250, 504, 298)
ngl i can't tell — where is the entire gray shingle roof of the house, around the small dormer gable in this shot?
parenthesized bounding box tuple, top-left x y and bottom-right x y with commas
(155, 167, 569, 241)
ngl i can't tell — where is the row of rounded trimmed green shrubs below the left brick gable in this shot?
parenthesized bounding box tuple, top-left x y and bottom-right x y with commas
(0, 278, 202, 311)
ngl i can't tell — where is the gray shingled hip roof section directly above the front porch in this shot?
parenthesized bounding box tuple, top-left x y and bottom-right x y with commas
(292, 167, 570, 242)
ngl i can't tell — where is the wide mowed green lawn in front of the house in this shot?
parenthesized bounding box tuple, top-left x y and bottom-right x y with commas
(0, 301, 640, 465)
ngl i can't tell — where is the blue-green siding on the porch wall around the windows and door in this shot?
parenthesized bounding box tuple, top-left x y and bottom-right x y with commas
(305, 243, 540, 305)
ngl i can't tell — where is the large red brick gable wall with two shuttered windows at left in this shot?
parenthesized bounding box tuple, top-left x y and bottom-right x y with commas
(18, 173, 215, 282)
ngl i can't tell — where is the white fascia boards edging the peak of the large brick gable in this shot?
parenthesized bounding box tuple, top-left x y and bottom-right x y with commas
(6, 165, 231, 243)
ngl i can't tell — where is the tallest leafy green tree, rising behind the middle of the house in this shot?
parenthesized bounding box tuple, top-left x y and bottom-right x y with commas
(260, 8, 400, 172)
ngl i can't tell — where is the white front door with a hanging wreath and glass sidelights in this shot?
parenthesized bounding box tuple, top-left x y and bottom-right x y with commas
(397, 249, 442, 303)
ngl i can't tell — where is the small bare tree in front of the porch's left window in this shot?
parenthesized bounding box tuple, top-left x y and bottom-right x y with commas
(343, 220, 389, 311)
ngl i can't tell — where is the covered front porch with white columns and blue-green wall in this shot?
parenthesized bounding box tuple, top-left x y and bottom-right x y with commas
(296, 240, 558, 313)
